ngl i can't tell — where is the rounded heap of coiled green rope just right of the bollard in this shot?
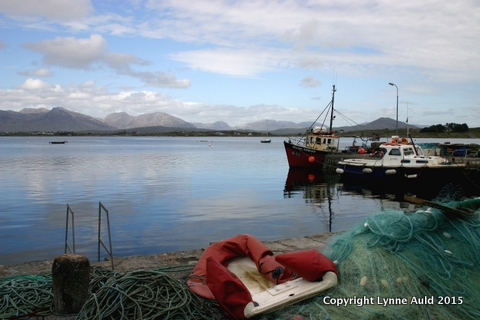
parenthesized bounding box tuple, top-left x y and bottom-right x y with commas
(77, 270, 213, 320)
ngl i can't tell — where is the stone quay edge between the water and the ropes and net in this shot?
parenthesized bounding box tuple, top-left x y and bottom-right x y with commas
(0, 232, 334, 278)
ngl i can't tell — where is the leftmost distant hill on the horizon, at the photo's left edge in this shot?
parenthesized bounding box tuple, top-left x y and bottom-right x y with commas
(0, 107, 115, 132)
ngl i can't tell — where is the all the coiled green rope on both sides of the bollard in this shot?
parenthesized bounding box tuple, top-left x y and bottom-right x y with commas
(0, 266, 221, 320)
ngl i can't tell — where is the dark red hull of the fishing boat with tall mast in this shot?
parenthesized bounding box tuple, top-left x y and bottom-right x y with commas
(283, 141, 331, 169)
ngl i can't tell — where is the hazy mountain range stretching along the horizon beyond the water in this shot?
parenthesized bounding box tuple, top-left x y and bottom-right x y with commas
(0, 107, 415, 134)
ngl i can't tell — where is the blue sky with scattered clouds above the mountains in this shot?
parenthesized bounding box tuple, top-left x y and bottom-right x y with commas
(0, 0, 480, 128)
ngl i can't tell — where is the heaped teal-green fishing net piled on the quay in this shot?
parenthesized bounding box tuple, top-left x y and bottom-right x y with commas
(265, 191, 480, 320)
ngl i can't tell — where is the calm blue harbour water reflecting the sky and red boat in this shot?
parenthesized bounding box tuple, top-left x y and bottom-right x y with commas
(0, 137, 480, 264)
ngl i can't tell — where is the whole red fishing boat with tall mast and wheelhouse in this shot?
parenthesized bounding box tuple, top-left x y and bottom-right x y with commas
(284, 85, 341, 169)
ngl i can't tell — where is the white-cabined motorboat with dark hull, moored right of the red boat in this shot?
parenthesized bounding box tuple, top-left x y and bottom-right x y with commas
(336, 136, 466, 185)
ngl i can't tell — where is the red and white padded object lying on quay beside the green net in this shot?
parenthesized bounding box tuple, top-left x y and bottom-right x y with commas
(187, 234, 337, 319)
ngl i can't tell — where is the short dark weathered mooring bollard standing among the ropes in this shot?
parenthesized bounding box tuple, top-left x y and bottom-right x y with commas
(52, 254, 90, 314)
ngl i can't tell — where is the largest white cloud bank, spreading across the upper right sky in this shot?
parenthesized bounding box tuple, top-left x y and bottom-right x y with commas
(143, 0, 480, 82)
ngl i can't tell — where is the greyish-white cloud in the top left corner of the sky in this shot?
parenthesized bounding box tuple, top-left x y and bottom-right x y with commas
(0, 0, 93, 20)
